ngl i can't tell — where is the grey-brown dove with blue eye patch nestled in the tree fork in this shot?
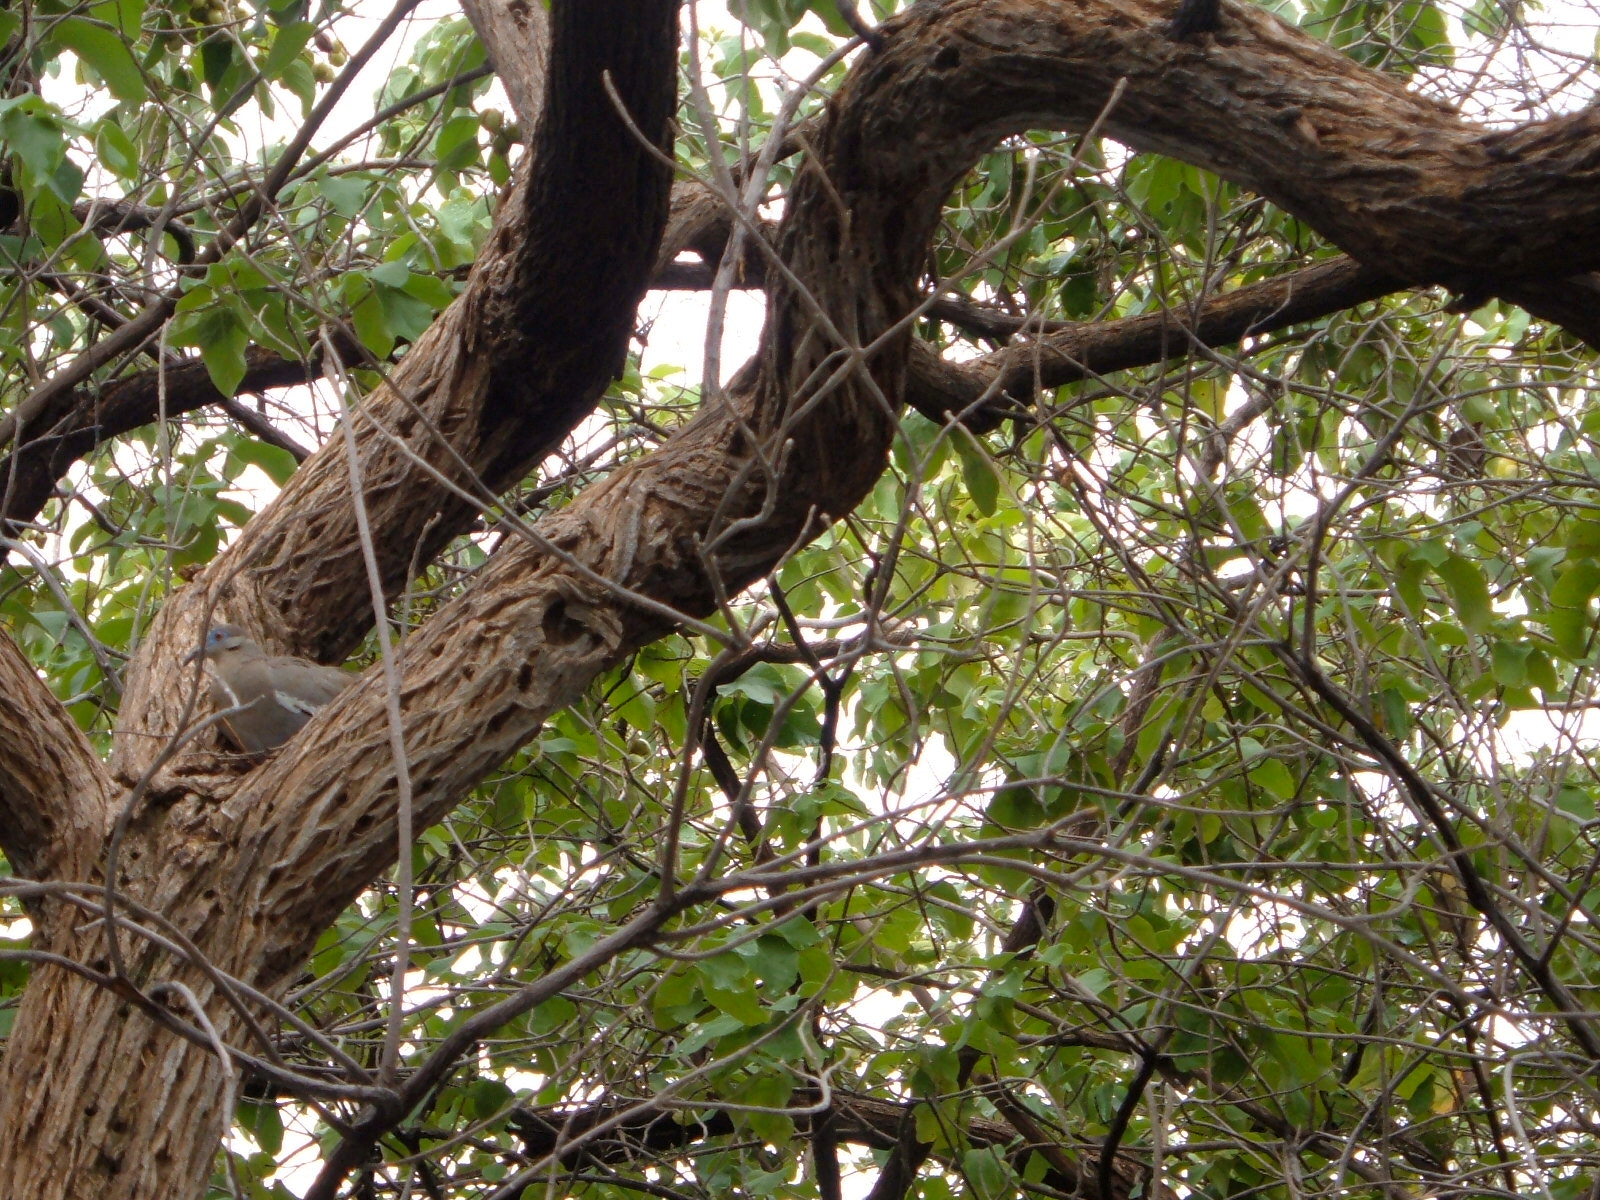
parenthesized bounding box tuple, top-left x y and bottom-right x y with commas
(184, 626, 355, 754)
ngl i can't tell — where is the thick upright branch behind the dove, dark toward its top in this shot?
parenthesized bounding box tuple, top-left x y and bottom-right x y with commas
(114, 5, 675, 779)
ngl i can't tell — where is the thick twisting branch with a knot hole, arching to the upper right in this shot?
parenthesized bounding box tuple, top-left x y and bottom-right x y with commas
(181, 0, 1600, 966)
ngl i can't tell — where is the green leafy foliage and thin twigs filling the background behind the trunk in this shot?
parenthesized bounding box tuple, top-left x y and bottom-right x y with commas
(0, 0, 1600, 1200)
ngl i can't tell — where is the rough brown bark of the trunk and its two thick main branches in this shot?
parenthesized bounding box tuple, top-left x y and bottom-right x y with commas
(0, 0, 1600, 1200)
